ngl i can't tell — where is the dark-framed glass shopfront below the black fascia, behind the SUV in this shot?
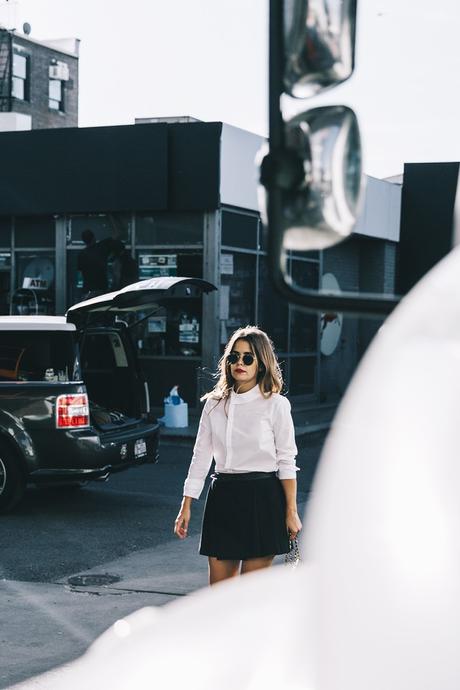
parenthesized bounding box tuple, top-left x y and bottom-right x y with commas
(0, 207, 320, 407)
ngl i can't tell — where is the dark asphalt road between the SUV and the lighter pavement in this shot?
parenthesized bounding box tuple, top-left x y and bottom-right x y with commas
(0, 439, 321, 582)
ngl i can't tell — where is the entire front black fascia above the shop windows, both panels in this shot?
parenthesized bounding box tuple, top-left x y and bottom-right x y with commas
(0, 123, 222, 215)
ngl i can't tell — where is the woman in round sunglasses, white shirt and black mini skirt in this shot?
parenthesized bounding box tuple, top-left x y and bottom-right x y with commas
(174, 326, 302, 584)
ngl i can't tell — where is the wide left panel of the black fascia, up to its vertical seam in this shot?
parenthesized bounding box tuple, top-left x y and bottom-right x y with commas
(0, 125, 168, 215)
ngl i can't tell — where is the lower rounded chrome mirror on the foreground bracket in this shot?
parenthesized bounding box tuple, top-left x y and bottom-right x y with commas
(261, 106, 362, 251)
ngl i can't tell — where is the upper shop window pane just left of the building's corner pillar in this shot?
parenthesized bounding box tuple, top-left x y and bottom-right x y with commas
(136, 212, 204, 246)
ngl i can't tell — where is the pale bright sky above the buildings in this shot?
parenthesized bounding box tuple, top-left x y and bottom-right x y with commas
(0, 0, 460, 177)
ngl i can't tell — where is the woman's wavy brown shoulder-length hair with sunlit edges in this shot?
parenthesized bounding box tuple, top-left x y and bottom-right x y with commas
(201, 326, 283, 401)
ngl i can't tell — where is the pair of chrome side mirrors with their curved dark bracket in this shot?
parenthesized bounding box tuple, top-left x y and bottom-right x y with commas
(260, 0, 398, 316)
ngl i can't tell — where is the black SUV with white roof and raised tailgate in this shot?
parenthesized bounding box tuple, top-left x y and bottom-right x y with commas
(0, 277, 215, 512)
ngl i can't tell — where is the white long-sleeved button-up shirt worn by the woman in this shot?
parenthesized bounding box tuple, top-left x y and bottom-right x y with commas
(184, 386, 299, 498)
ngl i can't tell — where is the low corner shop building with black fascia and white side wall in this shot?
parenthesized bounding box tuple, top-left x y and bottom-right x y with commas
(0, 121, 406, 408)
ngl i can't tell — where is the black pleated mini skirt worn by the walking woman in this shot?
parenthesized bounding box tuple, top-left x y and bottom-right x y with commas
(200, 472, 289, 560)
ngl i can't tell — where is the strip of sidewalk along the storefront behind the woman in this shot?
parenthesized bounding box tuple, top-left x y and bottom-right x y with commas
(160, 398, 339, 445)
